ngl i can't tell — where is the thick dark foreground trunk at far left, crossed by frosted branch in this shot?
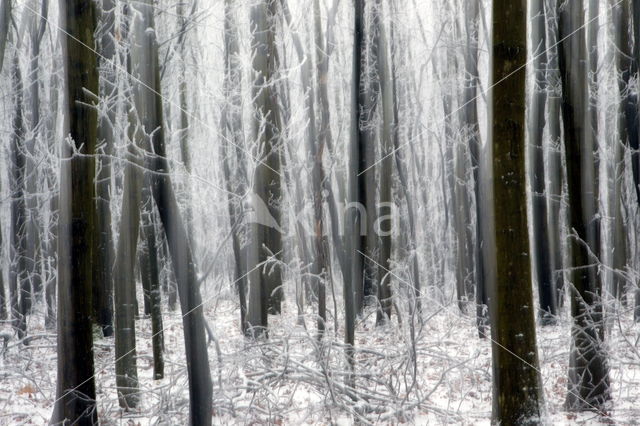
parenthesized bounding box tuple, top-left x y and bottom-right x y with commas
(51, 0, 98, 425)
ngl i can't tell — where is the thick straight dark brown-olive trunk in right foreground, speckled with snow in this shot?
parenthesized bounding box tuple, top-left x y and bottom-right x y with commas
(490, 0, 544, 424)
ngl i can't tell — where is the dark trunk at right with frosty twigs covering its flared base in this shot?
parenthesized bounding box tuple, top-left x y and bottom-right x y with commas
(558, 2, 611, 411)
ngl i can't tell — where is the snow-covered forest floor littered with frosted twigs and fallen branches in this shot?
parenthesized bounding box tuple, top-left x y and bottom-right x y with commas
(0, 284, 640, 425)
